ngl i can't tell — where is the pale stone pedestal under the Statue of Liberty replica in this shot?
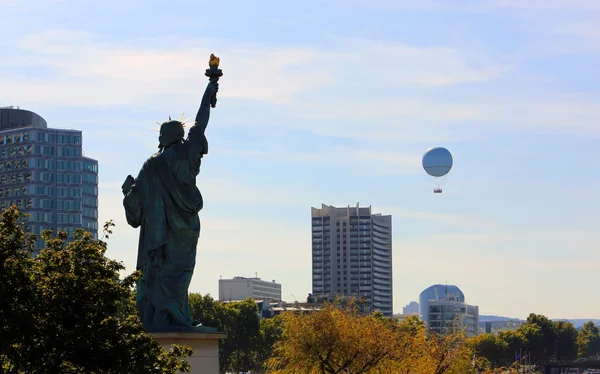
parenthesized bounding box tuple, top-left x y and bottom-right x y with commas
(153, 332, 227, 374)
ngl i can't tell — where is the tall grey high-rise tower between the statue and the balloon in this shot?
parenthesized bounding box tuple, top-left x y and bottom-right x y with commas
(312, 204, 392, 317)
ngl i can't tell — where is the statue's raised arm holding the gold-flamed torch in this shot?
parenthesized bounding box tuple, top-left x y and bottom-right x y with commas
(188, 55, 223, 155)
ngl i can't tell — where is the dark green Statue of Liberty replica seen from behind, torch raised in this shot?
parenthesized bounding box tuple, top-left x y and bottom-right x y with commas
(122, 55, 222, 332)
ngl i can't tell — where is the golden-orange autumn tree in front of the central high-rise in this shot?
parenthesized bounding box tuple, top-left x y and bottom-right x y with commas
(267, 304, 472, 374)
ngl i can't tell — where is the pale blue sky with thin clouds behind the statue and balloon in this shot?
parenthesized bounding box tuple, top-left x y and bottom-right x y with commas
(0, 0, 600, 318)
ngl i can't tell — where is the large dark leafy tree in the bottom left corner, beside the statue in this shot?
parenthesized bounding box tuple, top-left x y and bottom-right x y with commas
(0, 207, 191, 373)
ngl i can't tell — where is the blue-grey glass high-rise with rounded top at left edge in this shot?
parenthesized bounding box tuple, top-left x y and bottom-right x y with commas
(0, 106, 98, 249)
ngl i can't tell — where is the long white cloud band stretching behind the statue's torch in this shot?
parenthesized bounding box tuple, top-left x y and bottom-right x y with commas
(1, 30, 506, 106)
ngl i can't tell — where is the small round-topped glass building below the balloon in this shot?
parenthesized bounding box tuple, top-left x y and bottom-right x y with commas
(419, 284, 479, 336)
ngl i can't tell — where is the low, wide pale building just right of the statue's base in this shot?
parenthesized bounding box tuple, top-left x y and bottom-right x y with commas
(219, 277, 281, 301)
